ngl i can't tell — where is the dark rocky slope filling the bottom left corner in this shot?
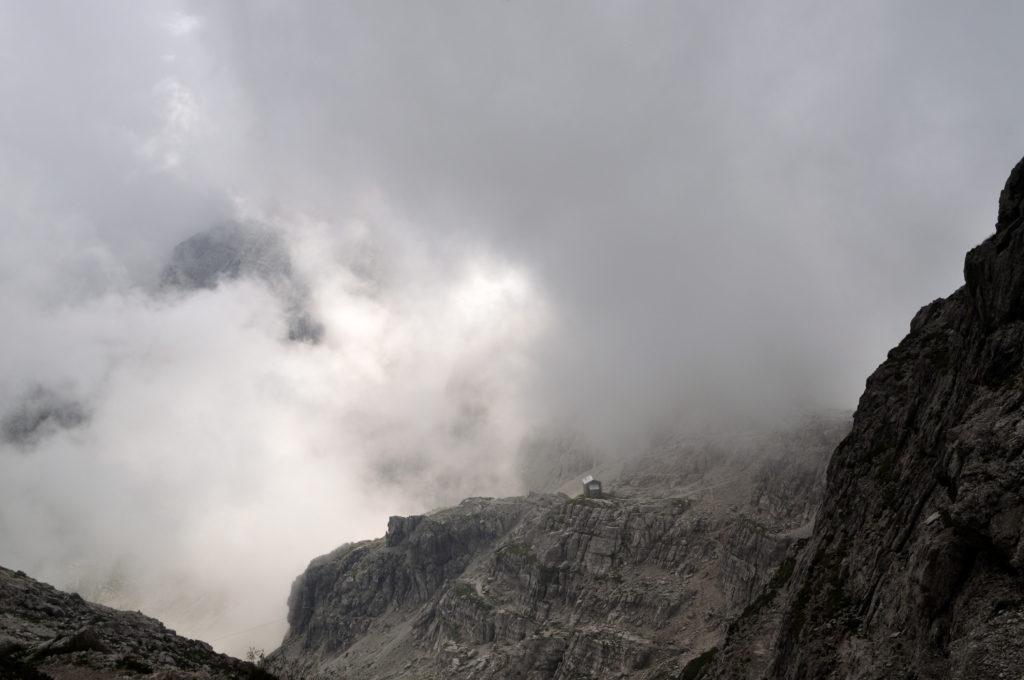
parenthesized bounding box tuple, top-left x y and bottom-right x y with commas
(0, 567, 273, 680)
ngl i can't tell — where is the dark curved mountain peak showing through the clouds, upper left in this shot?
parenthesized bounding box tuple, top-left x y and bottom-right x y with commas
(161, 222, 324, 343)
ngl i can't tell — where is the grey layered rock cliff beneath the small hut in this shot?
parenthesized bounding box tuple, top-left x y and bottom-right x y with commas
(270, 417, 847, 679)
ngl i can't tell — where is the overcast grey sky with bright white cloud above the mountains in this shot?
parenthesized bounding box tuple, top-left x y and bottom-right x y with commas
(0, 0, 1024, 649)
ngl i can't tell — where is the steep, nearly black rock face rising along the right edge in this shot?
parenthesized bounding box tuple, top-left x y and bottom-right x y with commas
(710, 162, 1024, 680)
